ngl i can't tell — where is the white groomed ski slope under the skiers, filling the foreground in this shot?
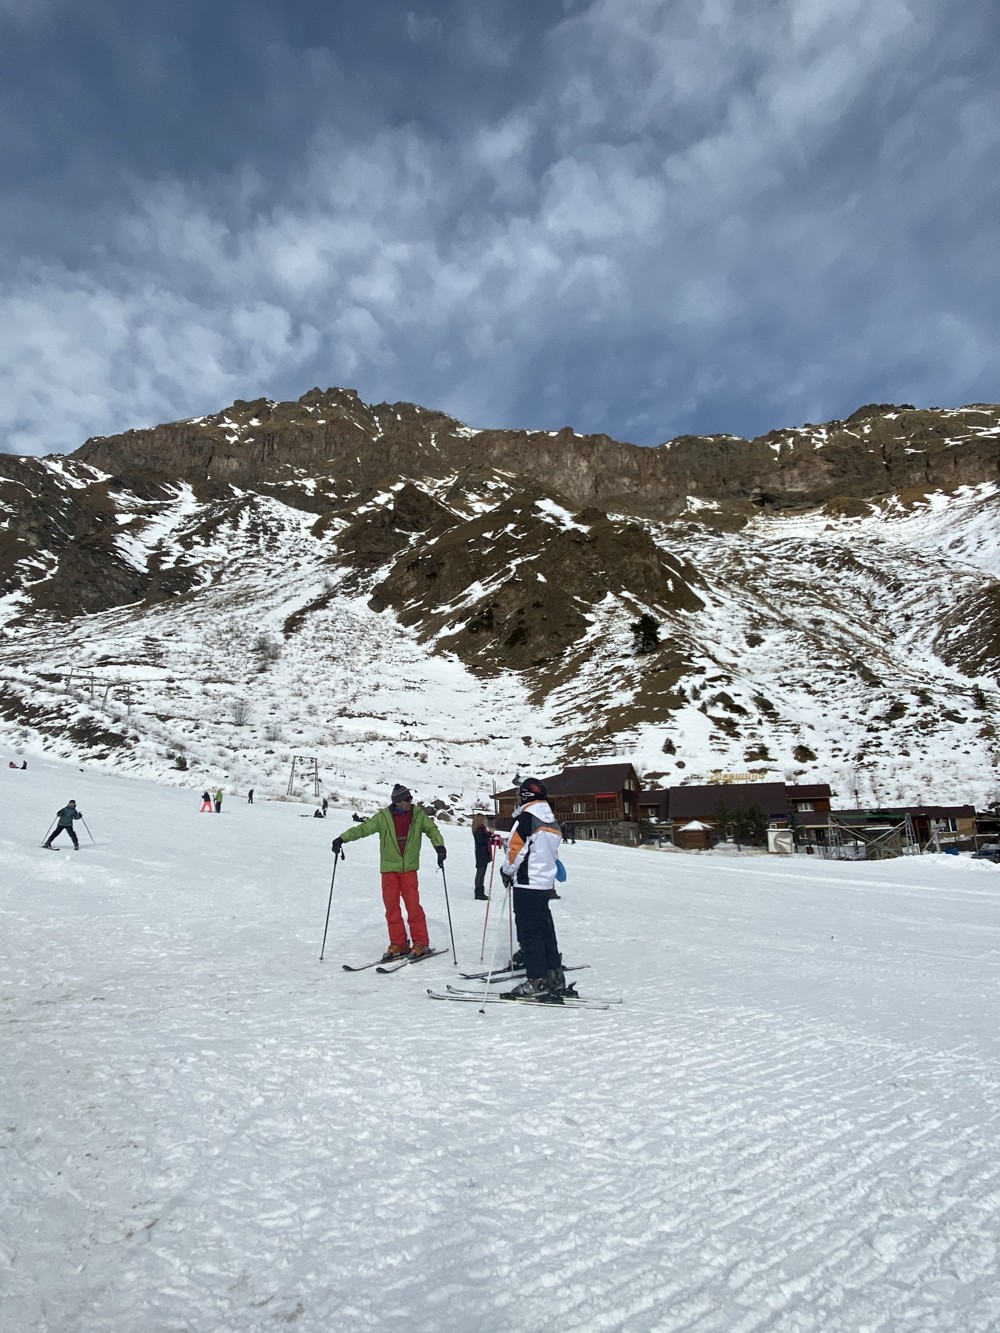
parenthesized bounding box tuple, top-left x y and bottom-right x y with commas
(0, 762, 1000, 1333)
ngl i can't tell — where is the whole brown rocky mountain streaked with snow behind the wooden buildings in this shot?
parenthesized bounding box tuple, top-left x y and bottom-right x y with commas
(0, 389, 1000, 813)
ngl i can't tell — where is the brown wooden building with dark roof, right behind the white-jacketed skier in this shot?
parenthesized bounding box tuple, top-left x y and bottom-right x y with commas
(493, 764, 640, 845)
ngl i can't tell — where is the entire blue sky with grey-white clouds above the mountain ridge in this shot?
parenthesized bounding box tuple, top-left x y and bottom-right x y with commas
(0, 0, 1000, 453)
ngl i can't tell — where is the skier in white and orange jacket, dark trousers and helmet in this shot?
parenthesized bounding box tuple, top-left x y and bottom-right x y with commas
(500, 777, 567, 1004)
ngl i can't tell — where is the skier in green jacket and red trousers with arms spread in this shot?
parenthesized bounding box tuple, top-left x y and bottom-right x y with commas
(332, 782, 448, 961)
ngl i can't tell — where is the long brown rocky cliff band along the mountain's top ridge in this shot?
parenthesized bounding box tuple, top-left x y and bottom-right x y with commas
(73, 389, 1000, 517)
